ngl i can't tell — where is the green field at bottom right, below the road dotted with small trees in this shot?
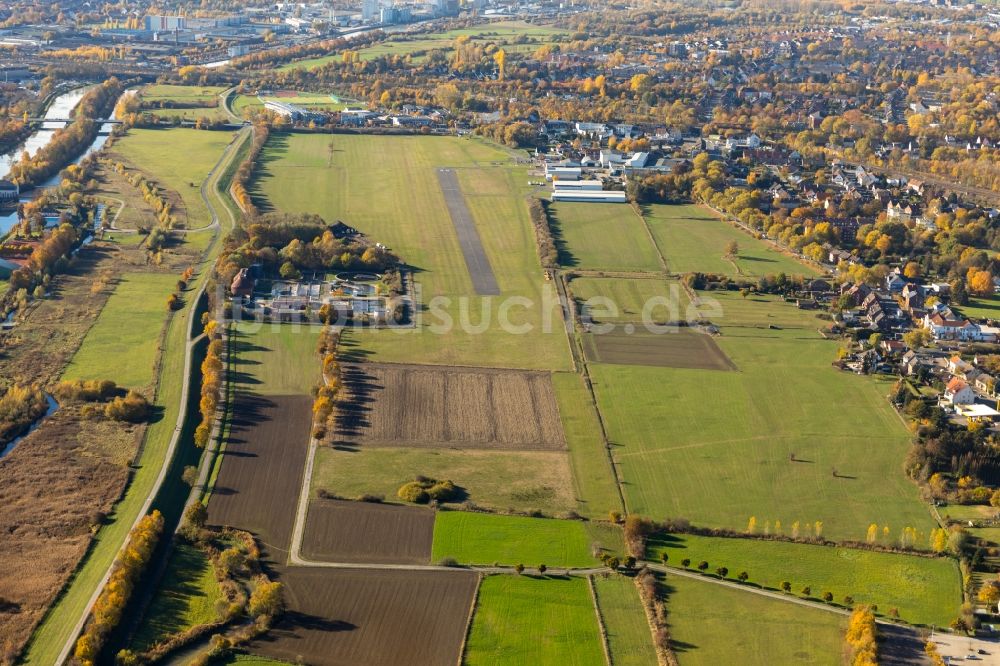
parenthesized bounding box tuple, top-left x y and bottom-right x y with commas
(666, 576, 847, 666)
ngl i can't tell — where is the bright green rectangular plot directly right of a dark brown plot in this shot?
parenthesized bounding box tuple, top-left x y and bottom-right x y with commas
(431, 511, 597, 568)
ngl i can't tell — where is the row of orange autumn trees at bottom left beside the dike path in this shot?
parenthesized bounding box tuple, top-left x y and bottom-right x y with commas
(73, 511, 163, 666)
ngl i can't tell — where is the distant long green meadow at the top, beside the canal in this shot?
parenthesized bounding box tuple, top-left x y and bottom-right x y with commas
(279, 21, 569, 70)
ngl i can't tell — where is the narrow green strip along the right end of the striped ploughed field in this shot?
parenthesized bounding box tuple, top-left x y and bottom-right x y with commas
(552, 372, 624, 519)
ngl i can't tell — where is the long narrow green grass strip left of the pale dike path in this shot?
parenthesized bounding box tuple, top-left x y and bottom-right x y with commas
(23, 130, 248, 666)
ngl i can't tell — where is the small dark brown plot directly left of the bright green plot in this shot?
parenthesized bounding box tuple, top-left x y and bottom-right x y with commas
(302, 499, 434, 564)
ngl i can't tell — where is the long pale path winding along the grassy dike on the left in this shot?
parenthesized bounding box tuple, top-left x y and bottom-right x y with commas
(43, 129, 249, 664)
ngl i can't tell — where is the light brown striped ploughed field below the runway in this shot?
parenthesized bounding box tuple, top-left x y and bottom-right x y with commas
(336, 363, 566, 450)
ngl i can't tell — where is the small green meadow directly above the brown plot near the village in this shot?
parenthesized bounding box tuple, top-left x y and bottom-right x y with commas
(570, 277, 697, 324)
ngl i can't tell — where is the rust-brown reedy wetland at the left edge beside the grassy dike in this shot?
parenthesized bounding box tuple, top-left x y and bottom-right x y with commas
(0, 408, 141, 663)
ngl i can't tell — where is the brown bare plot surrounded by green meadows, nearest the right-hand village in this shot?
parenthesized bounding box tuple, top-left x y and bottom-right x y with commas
(583, 327, 737, 370)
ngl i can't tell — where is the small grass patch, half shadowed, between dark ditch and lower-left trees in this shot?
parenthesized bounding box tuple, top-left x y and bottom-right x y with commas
(132, 544, 223, 650)
